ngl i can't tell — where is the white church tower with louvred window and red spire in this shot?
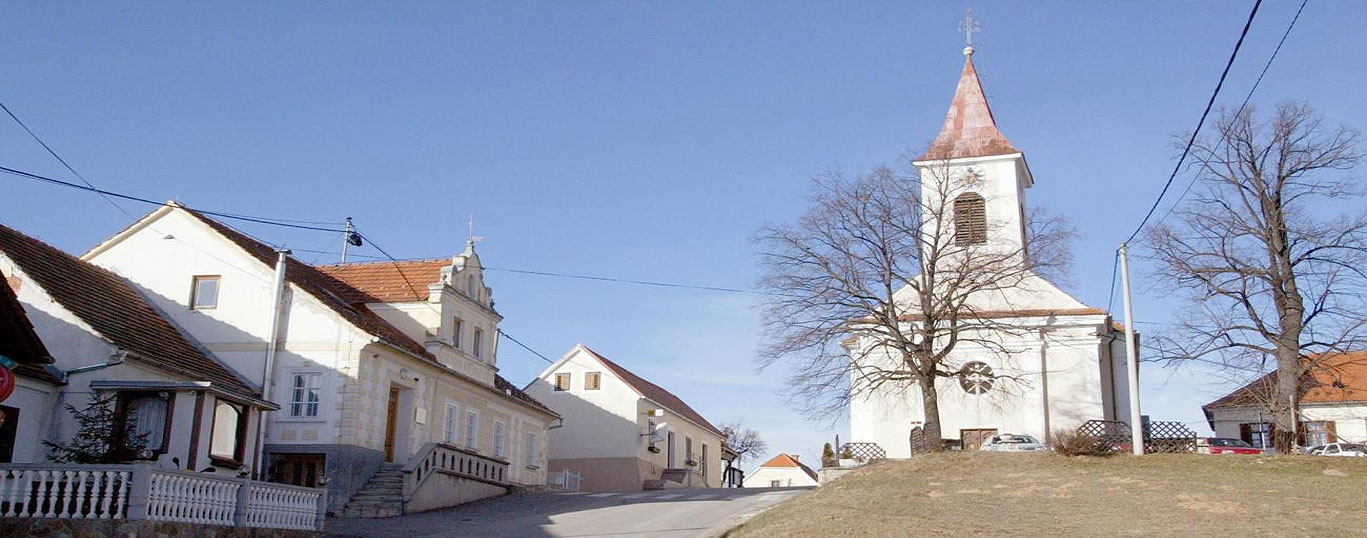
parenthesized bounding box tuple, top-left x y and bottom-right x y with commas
(913, 41, 1035, 262)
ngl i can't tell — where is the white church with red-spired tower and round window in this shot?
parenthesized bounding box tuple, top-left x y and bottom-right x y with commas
(850, 39, 1129, 457)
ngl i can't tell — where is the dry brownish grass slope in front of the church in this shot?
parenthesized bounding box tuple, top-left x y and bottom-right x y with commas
(727, 452, 1367, 538)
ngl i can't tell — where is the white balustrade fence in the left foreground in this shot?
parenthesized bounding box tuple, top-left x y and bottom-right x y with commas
(0, 463, 327, 530)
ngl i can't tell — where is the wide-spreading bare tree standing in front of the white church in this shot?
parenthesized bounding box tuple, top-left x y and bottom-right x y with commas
(756, 158, 1072, 449)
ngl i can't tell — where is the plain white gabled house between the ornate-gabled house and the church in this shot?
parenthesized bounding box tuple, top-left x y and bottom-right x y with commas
(526, 344, 734, 492)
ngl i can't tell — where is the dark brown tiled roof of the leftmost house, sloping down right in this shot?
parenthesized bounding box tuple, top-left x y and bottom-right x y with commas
(0, 225, 261, 397)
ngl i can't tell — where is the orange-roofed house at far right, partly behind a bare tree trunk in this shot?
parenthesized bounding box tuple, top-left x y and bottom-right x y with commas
(1202, 351, 1367, 447)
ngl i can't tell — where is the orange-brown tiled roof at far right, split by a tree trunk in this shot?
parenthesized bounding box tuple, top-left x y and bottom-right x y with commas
(1202, 351, 1367, 410)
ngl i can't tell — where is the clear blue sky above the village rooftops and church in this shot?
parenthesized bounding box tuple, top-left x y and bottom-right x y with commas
(0, 1, 1367, 466)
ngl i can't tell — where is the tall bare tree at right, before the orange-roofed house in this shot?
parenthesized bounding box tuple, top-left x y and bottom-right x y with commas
(1148, 104, 1367, 453)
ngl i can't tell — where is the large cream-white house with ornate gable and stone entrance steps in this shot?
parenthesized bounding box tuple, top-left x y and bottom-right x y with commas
(83, 202, 556, 516)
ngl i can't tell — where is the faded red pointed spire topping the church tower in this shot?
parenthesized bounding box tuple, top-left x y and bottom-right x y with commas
(921, 53, 1021, 160)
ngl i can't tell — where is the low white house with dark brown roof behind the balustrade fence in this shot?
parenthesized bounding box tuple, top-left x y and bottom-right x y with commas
(0, 225, 278, 472)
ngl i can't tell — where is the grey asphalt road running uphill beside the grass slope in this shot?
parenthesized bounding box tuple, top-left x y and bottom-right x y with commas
(327, 487, 807, 538)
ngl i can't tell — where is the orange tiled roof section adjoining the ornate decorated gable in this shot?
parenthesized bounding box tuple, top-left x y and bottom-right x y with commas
(314, 258, 451, 303)
